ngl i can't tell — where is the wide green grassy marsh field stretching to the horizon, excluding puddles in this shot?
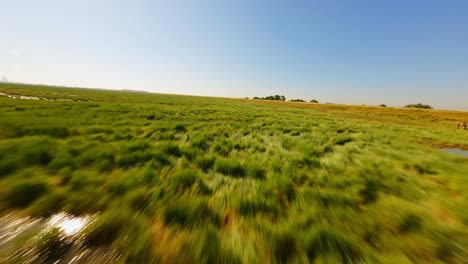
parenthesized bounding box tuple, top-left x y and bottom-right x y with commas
(0, 84, 468, 263)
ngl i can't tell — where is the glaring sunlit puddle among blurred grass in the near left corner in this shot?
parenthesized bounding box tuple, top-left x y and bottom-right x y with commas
(0, 213, 121, 264)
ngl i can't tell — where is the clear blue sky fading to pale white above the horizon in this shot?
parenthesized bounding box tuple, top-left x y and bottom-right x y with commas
(0, 0, 468, 110)
